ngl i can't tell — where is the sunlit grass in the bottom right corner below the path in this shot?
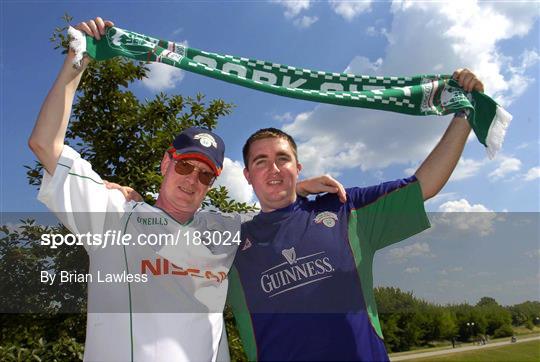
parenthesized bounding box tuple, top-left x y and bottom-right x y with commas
(409, 340, 540, 362)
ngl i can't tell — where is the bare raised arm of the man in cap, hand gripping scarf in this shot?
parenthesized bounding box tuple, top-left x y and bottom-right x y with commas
(28, 17, 113, 175)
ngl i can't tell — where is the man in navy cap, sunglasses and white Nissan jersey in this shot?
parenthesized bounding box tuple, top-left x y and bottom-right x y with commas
(29, 18, 342, 361)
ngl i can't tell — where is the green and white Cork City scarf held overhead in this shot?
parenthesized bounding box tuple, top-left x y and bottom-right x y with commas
(68, 27, 512, 158)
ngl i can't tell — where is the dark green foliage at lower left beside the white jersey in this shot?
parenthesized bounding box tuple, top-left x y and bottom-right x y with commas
(0, 220, 88, 361)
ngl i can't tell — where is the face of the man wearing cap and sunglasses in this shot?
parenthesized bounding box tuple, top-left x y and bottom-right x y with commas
(160, 158, 213, 213)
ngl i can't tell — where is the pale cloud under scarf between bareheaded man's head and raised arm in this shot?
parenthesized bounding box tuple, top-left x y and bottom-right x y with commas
(283, 105, 444, 175)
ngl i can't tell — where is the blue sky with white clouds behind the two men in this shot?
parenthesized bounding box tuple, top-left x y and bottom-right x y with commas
(0, 0, 540, 304)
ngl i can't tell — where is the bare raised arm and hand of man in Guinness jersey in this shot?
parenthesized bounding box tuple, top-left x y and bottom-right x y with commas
(415, 69, 484, 200)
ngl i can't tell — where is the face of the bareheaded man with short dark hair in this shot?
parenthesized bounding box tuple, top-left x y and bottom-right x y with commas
(244, 138, 302, 212)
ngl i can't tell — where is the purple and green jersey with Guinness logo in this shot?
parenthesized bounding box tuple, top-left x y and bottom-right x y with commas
(229, 176, 429, 361)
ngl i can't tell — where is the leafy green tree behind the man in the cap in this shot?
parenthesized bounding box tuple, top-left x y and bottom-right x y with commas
(0, 14, 252, 360)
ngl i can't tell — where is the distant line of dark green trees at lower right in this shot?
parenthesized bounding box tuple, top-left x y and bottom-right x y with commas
(375, 287, 540, 352)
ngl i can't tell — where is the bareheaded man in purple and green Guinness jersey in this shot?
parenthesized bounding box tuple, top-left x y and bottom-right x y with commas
(229, 69, 483, 361)
